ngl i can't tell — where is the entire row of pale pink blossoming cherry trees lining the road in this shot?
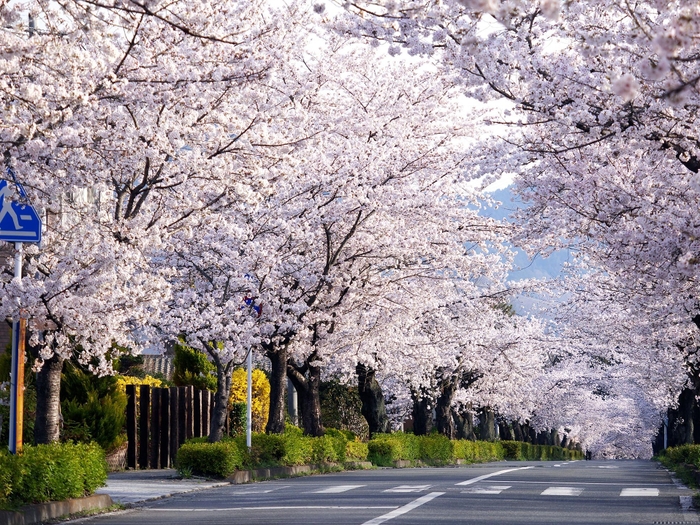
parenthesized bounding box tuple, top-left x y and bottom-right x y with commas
(0, 0, 700, 454)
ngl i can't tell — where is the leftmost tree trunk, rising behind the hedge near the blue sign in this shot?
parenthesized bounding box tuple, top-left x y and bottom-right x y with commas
(34, 354, 64, 445)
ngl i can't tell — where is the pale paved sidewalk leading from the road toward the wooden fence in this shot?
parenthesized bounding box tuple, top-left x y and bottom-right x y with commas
(96, 469, 230, 505)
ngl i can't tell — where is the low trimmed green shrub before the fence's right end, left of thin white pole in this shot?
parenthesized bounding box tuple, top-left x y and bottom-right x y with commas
(176, 438, 243, 478)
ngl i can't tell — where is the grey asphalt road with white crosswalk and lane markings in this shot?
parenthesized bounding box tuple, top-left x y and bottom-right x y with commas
(80, 461, 700, 525)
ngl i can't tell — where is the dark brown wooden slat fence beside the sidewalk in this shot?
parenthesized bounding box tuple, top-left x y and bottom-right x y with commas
(126, 385, 214, 469)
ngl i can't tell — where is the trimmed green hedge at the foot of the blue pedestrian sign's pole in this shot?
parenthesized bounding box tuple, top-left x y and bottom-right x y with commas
(0, 443, 107, 509)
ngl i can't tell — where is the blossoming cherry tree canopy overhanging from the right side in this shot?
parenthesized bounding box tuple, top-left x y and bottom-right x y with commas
(330, 0, 700, 450)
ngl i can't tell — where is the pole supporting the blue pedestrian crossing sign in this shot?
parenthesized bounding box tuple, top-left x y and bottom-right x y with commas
(9, 242, 25, 454)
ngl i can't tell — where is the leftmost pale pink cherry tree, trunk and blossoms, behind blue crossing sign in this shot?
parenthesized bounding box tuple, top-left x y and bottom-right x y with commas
(0, 1, 312, 442)
